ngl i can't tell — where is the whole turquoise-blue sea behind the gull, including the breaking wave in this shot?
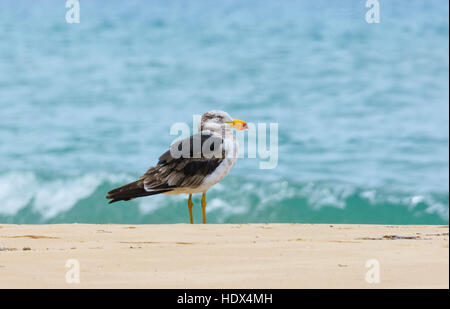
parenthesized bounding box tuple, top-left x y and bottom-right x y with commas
(0, 0, 449, 224)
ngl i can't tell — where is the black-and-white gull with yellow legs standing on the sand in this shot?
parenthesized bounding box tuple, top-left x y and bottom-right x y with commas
(106, 110, 248, 224)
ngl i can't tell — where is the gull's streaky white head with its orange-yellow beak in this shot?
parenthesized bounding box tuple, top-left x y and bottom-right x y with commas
(200, 110, 248, 131)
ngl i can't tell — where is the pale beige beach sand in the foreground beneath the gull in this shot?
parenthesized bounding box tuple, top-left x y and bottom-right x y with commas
(0, 224, 449, 289)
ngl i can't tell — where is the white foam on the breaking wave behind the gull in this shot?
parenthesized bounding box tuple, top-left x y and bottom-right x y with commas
(0, 172, 449, 222)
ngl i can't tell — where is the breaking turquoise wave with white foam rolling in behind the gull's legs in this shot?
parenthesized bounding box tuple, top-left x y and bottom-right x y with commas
(0, 172, 449, 224)
